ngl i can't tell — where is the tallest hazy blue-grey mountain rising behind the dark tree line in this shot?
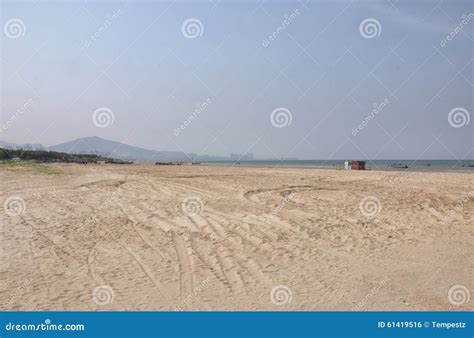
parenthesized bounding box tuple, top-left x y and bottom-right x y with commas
(47, 136, 190, 162)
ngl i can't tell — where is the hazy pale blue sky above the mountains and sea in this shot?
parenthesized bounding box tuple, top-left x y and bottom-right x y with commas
(0, 0, 474, 159)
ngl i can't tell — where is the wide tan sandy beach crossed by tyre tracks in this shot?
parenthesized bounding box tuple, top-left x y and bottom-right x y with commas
(0, 164, 474, 311)
